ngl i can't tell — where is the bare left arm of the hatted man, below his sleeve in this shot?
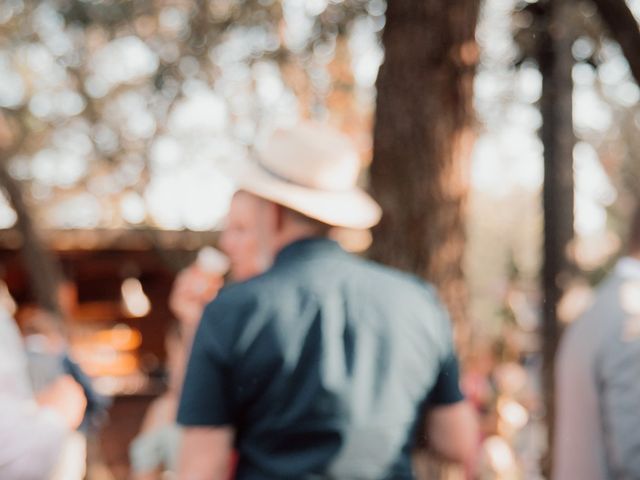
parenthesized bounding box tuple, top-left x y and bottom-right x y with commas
(178, 427, 233, 480)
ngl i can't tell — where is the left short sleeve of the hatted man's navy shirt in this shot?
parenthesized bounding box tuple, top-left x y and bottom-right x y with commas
(178, 301, 233, 426)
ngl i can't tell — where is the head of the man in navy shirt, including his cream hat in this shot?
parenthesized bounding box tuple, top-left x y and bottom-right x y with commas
(221, 123, 381, 280)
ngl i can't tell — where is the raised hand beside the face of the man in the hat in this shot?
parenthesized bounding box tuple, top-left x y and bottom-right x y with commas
(169, 265, 222, 328)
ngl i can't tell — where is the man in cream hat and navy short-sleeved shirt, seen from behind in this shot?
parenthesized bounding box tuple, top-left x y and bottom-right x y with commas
(178, 124, 476, 480)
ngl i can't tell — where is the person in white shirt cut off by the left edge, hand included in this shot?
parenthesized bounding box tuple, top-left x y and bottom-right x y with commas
(0, 306, 86, 480)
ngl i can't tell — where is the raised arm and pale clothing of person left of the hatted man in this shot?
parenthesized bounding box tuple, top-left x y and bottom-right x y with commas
(129, 247, 229, 480)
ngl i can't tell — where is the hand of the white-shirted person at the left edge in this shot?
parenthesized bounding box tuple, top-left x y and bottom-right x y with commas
(36, 375, 87, 430)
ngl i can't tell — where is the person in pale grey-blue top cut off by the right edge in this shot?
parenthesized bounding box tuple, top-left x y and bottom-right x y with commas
(553, 209, 640, 480)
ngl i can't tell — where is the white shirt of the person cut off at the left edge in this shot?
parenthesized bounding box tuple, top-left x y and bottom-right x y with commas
(0, 309, 68, 480)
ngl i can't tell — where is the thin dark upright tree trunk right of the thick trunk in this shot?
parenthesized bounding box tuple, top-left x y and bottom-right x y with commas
(538, 0, 575, 475)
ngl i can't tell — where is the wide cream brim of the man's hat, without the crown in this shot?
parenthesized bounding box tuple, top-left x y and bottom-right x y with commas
(222, 159, 382, 229)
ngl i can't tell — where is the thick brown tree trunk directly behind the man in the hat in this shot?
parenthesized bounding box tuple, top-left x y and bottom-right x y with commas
(370, 0, 480, 344)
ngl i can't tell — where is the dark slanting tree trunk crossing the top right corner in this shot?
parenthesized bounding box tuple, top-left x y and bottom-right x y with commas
(593, 0, 640, 85)
